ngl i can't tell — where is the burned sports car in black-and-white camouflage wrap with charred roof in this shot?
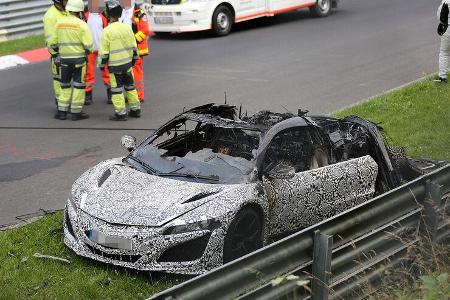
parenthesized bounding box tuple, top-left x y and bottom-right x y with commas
(64, 104, 440, 274)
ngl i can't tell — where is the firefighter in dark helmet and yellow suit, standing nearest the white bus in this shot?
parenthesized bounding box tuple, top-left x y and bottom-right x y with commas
(99, 0, 141, 121)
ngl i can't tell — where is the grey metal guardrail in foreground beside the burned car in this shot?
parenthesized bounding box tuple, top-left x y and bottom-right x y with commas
(150, 165, 450, 300)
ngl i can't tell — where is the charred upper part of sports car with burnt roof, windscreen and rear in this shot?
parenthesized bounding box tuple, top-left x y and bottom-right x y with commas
(127, 104, 440, 194)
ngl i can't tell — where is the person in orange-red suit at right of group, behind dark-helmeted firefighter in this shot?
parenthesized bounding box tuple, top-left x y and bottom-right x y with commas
(131, 0, 150, 103)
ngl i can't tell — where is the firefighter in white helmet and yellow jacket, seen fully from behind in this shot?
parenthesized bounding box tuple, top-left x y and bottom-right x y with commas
(50, 0, 93, 121)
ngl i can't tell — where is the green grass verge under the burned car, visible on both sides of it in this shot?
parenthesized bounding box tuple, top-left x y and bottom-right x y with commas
(0, 80, 450, 299)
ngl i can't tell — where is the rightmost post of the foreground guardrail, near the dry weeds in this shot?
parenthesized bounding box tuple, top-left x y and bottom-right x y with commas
(422, 180, 443, 243)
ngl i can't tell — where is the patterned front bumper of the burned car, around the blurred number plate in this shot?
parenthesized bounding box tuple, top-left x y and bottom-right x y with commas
(64, 201, 224, 275)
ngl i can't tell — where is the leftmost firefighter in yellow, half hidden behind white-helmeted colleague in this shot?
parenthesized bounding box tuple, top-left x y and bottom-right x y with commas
(43, 0, 67, 105)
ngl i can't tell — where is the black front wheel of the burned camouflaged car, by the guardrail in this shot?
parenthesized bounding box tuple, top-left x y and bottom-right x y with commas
(223, 207, 263, 264)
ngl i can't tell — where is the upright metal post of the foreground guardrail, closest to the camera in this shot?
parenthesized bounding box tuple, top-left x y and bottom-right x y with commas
(311, 230, 333, 300)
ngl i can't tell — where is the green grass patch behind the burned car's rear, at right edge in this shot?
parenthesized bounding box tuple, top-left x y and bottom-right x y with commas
(335, 80, 450, 160)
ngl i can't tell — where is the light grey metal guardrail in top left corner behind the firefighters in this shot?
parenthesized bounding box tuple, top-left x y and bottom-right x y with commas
(0, 0, 52, 41)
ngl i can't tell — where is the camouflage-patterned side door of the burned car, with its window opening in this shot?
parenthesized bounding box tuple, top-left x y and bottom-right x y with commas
(263, 127, 378, 236)
